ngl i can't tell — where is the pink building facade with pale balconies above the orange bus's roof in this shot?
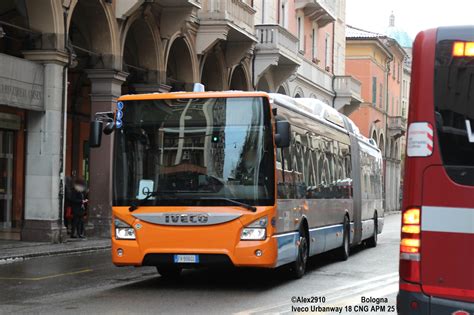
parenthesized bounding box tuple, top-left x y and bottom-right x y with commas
(254, 0, 361, 113)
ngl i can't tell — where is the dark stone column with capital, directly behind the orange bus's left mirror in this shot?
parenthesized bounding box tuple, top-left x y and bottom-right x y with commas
(86, 69, 128, 237)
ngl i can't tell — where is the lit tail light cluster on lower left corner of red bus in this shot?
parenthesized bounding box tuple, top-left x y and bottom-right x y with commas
(400, 207, 421, 282)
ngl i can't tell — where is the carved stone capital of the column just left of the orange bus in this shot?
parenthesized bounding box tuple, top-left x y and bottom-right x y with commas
(85, 69, 128, 102)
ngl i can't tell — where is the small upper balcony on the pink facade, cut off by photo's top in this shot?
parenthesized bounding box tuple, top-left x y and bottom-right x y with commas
(296, 0, 336, 27)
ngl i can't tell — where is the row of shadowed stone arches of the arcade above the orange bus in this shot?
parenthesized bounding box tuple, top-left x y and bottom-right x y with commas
(0, 0, 251, 89)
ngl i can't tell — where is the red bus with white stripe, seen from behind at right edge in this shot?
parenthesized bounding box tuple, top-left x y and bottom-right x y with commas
(397, 26, 474, 315)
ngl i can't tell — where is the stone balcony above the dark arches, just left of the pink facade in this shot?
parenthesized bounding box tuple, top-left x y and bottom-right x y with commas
(196, 0, 257, 56)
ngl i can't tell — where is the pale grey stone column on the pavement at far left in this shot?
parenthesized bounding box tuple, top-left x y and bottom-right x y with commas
(21, 51, 67, 242)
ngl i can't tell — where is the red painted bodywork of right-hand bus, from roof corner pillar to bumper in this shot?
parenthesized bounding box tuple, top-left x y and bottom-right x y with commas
(403, 29, 474, 302)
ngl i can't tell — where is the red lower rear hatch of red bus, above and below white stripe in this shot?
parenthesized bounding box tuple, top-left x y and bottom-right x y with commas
(421, 166, 474, 302)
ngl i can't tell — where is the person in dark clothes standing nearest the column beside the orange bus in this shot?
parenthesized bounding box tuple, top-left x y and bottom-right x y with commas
(69, 178, 88, 238)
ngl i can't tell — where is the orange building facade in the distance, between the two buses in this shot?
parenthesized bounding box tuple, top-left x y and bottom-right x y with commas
(346, 22, 410, 211)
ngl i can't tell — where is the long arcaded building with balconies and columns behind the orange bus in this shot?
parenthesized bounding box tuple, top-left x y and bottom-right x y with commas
(0, 0, 361, 241)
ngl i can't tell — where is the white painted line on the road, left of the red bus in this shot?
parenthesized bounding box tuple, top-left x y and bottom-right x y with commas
(235, 272, 398, 315)
